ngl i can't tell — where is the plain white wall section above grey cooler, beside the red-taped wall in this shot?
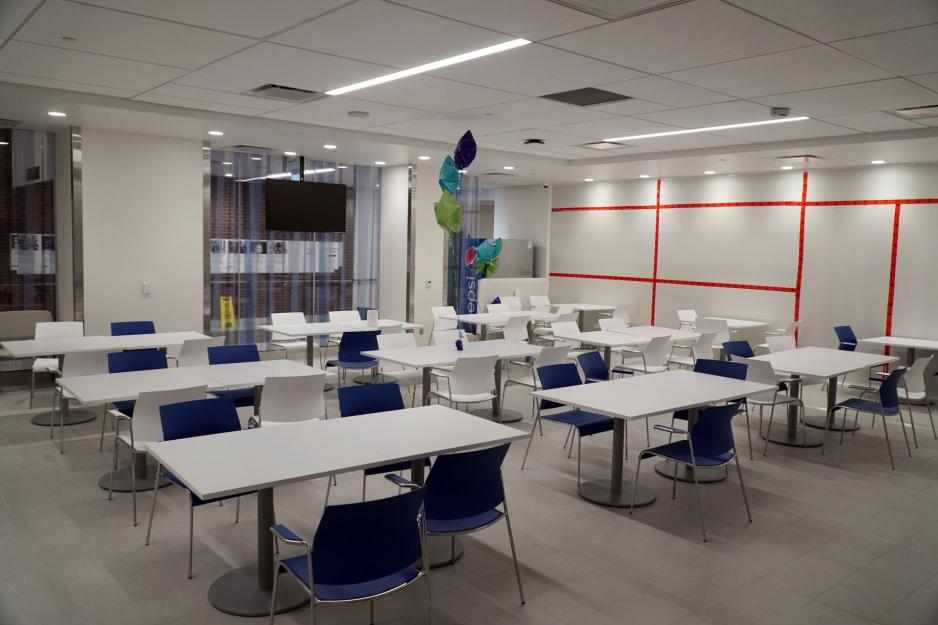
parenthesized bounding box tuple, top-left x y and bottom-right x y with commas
(494, 185, 551, 278)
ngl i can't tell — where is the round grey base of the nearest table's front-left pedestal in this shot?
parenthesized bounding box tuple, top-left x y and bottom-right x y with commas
(208, 564, 309, 616)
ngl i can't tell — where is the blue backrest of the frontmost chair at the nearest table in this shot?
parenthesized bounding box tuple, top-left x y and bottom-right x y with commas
(310, 488, 426, 586)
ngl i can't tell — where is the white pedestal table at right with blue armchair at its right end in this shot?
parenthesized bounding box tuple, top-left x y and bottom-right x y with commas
(756, 347, 899, 447)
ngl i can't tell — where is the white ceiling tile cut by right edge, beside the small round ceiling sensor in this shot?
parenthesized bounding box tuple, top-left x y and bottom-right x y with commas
(755, 78, 938, 117)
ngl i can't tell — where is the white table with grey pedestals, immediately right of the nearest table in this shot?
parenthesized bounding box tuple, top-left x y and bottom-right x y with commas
(533, 371, 772, 508)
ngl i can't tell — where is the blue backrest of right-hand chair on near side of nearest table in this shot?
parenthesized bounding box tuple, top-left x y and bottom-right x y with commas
(424, 443, 510, 521)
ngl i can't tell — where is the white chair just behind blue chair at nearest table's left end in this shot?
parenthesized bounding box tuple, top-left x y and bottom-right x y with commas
(107, 385, 208, 527)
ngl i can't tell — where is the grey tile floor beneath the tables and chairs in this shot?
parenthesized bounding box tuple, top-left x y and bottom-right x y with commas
(0, 366, 938, 625)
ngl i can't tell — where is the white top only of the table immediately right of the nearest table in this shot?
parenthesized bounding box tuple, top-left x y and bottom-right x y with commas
(533, 370, 774, 420)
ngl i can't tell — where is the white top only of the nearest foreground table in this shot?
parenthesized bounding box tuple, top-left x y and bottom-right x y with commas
(147, 405, 528, 499)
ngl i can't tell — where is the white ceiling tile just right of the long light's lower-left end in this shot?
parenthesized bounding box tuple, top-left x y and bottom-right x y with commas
(355, 76, 524, 113)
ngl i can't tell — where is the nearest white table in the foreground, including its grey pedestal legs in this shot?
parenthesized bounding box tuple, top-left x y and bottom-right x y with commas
(148, 405, 527, 616)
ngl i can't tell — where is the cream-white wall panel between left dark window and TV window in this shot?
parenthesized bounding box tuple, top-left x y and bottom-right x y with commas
(82, 128, 204, 334)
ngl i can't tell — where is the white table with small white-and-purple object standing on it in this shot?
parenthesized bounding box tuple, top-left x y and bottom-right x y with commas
(362, 339, 541, 423)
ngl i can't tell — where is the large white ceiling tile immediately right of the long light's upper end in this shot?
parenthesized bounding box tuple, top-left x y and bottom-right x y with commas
(547, 0, 812, 74)
